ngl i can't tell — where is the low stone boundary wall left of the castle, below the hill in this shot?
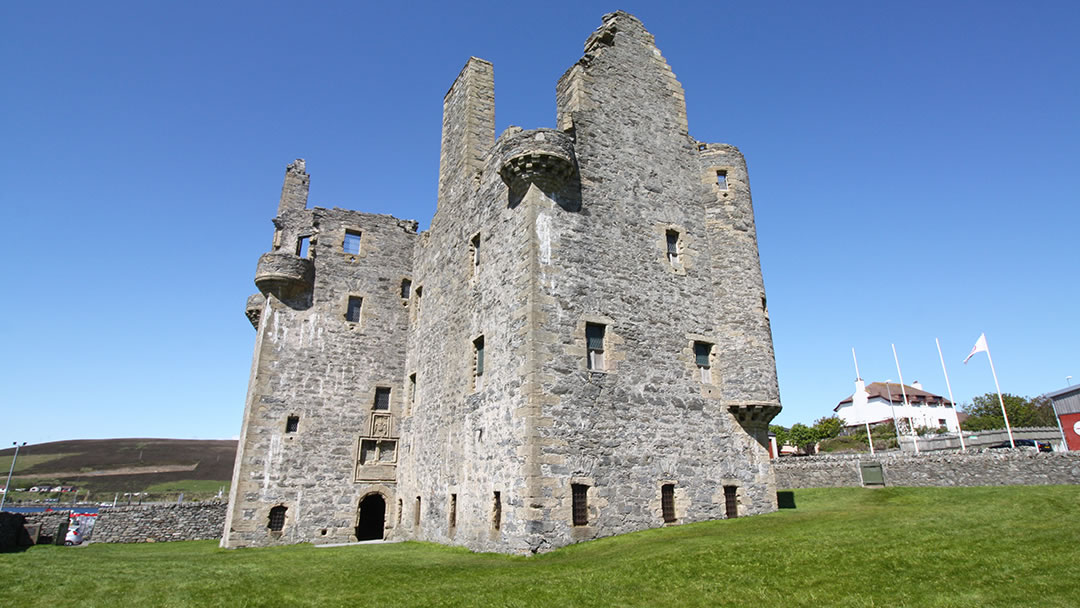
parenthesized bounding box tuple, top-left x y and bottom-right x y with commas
(26, 502, 228, 542)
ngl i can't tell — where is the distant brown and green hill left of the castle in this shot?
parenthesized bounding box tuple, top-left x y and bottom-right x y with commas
(0, 438, 237, 502)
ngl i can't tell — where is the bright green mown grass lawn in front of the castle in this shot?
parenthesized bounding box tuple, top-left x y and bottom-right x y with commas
(0, 486, 1080, 608)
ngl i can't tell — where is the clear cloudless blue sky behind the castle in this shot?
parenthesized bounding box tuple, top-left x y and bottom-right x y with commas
(0, 0, 1080, 446)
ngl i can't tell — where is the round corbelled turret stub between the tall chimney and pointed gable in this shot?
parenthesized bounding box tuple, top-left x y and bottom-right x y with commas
(498, 127, 577, 192)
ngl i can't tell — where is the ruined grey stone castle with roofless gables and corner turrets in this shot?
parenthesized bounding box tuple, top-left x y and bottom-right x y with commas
(221, 12, 780, 554)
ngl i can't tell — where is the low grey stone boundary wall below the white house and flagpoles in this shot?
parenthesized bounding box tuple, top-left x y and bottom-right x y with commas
(772, 449, 1080, 490)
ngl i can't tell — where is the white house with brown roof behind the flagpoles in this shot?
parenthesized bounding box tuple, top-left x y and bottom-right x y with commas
(833, 379, 960, 433)
